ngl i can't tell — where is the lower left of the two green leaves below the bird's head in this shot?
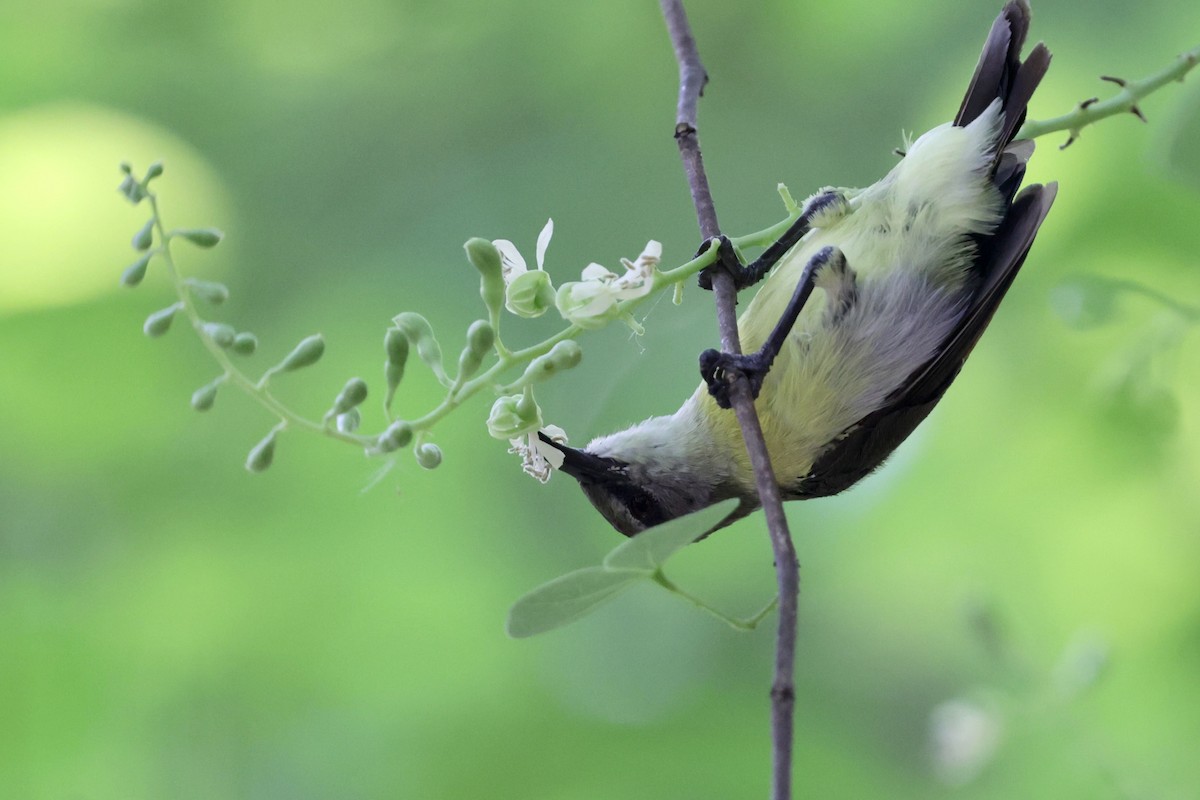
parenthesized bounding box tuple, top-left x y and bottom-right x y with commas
(505, 566, 646, 639)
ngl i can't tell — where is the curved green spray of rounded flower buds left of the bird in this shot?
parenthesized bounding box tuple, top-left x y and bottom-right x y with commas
(119, 163, 657, 473)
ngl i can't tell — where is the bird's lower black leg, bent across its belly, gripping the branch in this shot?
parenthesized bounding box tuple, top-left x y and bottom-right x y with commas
(700, 247, 854, 408)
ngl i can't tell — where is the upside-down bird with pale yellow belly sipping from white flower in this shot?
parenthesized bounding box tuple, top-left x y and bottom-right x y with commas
(542, 0, 1057, 536)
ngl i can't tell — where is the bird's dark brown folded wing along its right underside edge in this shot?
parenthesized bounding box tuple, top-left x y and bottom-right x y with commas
(786, 184, 1058, 500)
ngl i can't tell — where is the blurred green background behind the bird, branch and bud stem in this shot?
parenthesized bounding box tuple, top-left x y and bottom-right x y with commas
(0, 0, 1200, 800)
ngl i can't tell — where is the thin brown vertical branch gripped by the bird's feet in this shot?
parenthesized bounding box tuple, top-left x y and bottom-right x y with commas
(660, 0, 800, 800)
